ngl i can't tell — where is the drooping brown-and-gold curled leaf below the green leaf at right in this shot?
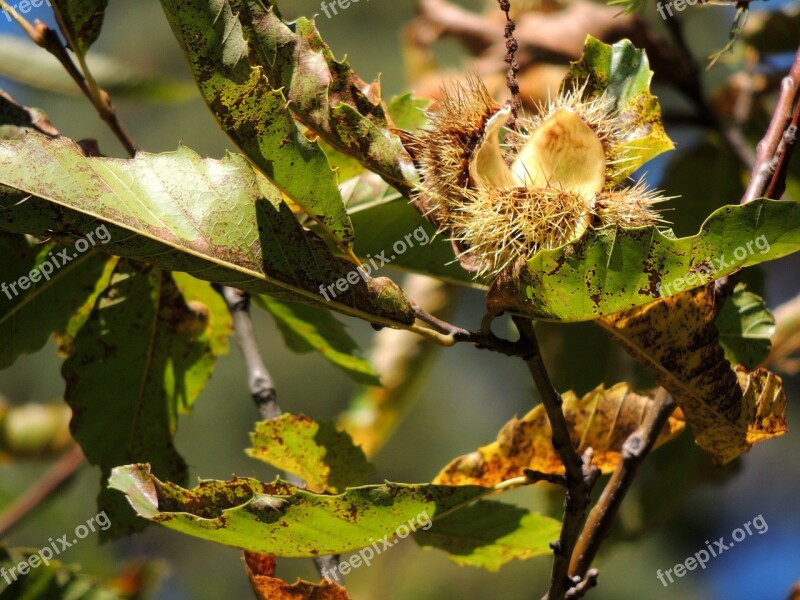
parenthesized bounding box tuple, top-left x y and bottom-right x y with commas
(597, 285, 786, 464)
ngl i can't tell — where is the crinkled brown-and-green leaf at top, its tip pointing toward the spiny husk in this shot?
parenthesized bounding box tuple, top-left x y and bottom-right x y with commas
(220, 0, 417, 193)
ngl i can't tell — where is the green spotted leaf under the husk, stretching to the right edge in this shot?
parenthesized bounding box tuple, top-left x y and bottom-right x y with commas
(488, 199, 800, 321)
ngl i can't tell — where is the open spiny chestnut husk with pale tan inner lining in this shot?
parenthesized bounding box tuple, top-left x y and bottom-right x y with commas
(414, 78, 667, 277)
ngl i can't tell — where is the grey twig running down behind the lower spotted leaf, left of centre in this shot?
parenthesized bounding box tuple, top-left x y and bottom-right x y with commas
(216, 286, 344, 586)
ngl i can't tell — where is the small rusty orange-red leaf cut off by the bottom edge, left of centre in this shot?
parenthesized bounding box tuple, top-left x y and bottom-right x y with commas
(244, 552, 350, 600)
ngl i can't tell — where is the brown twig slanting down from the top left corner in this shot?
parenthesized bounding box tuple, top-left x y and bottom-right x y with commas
(0, 0, 138, 157)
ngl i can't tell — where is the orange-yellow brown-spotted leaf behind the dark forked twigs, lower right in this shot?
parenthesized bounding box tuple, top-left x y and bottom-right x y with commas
(434, 383, 683, 486)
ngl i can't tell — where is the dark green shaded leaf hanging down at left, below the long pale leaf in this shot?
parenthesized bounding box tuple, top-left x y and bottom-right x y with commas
(62, 260, 214, 536)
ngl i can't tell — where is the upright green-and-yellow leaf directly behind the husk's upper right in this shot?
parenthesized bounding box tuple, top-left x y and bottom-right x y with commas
(561, 36, 674, 182)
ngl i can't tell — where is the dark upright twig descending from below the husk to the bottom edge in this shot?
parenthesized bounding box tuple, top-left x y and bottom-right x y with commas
(514, 317, 600, 600)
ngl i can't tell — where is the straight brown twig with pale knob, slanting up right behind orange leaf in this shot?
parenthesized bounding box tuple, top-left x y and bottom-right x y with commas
(570, 388, 675, 579)
